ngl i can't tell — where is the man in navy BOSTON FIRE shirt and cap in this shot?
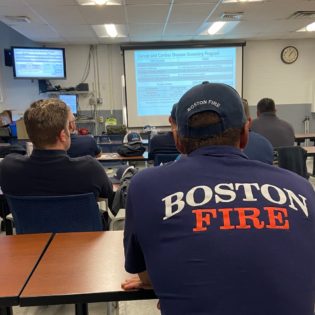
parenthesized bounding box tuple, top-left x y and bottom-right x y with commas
(122, 82, 315, 315)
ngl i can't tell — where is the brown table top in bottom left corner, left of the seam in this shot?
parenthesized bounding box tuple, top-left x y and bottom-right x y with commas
(0, 233, 52, 306)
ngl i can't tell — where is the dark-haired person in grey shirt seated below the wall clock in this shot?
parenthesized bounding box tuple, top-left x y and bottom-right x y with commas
(251, 98, 295, 148)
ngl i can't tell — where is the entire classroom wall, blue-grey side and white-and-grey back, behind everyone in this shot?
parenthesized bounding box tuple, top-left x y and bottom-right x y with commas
(0, 19, 315, 132)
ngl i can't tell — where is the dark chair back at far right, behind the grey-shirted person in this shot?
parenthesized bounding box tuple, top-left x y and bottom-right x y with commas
(276, 146, 309, 178)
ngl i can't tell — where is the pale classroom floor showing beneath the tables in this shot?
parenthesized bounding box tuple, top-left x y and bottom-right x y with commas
(1, 158, 315, 315)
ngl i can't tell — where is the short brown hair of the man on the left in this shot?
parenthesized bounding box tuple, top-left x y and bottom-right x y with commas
(24, 98, 69, 149)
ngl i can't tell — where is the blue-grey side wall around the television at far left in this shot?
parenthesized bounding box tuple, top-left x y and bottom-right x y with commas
(0, 22, 39, 119)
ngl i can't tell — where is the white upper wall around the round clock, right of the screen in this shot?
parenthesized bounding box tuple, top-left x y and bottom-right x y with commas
(244, 39, 315, 105)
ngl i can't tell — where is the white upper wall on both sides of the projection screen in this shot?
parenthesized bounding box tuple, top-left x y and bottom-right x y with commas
(51, 39, 315, 110)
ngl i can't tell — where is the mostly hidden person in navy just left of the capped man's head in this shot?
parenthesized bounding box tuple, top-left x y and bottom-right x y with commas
(148, 104, 179, 160)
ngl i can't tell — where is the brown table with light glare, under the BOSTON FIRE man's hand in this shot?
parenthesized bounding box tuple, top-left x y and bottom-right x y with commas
(20, 231, 155, 306)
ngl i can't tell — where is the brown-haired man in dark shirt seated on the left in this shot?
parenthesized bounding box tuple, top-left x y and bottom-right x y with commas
(0, 98, 114, 206)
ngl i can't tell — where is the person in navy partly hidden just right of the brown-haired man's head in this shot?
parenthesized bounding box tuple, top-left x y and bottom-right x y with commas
(67, 113, 102, 157)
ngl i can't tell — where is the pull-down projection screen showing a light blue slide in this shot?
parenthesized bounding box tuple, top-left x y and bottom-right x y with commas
(124, 46, 243, 127)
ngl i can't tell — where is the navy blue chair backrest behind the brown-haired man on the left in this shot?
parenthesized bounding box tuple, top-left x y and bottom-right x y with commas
(5, 193, 103, 234)
